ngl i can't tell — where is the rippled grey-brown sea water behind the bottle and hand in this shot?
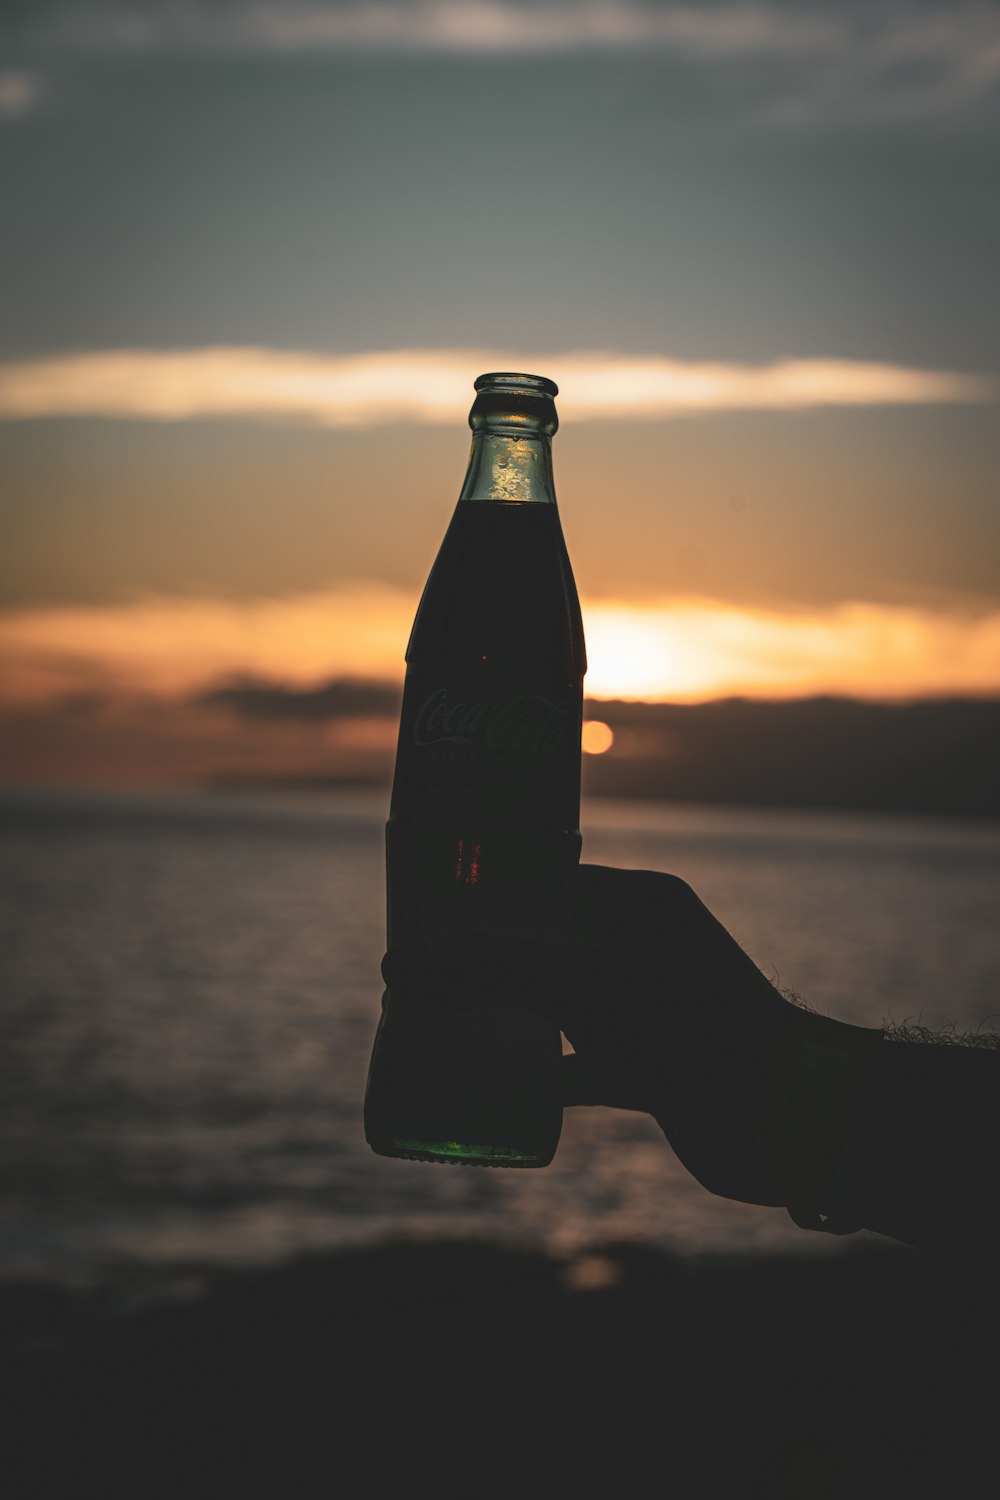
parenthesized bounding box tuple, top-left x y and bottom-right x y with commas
(0, 794, 1000, 1284)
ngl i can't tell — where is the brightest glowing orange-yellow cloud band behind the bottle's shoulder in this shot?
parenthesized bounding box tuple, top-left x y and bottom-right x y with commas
(0, 582, 1000, 705)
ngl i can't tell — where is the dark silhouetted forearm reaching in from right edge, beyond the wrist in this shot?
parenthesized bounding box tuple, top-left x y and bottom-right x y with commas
(762, 1013, 1000, 1263)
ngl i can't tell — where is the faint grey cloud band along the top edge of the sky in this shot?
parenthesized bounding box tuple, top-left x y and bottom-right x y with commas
(7, 0, 1000, 123)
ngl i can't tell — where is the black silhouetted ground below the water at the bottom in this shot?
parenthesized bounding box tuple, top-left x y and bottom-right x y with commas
(0, 1244, 1000, 1500)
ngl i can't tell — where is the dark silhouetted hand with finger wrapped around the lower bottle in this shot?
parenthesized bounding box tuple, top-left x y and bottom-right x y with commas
(384, 864, 852, 1205)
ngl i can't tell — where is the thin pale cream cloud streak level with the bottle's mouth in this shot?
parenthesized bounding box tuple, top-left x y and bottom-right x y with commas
(0, 348, 1000, 428)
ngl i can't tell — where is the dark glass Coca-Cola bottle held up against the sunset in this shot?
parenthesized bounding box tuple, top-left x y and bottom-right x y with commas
(364, 374, 586, 1167)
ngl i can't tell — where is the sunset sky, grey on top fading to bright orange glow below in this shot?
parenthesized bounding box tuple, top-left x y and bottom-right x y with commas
(0, 0, 1000, 776)
